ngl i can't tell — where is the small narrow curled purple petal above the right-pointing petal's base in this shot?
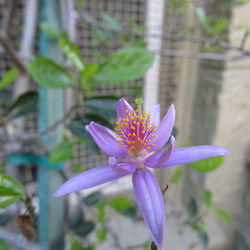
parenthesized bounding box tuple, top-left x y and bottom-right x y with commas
(144, 136, 176, 168)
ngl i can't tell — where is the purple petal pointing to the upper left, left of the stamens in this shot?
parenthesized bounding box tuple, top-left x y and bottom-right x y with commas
(85, 122, 127, 158)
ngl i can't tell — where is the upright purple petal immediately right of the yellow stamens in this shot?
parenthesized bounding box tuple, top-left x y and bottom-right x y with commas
(152, 104, 175, 150)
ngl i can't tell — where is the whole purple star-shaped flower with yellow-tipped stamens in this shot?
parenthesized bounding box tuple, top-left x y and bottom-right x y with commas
(55, 98, 229, 248)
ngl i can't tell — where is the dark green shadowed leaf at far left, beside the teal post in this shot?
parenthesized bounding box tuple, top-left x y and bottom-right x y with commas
(7, 90, 38, 119)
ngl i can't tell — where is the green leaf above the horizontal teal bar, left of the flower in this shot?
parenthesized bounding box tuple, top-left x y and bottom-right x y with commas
(49, 139, 74, 163)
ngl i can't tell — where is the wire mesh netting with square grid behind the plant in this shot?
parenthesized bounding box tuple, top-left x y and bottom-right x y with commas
(0, 0, 180, 180)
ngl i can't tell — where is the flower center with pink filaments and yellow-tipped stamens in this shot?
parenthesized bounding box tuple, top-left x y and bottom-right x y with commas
(115, 109, 157, 153)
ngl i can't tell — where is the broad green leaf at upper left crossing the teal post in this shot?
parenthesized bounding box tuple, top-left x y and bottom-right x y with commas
(28, 57, 74, 88)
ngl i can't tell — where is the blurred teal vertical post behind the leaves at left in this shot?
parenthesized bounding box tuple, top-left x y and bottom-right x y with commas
(38, 0, 64, 250)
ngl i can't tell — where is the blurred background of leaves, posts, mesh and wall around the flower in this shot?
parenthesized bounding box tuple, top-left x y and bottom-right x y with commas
(0, 0, 250, 250)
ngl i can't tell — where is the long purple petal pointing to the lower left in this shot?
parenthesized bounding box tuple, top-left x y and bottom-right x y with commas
(54, 165, 126, 197)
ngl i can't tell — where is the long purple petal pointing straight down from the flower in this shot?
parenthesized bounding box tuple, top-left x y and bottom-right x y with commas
(133, 168, 165, 248)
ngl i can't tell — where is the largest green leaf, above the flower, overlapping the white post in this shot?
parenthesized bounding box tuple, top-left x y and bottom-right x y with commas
(94, 48, 154, 83)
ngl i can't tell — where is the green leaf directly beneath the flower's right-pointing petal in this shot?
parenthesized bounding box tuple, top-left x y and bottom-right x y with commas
(187, 156, 224, 173)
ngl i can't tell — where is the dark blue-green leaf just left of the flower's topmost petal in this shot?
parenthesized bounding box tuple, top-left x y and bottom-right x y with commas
(85, 96, 119, 118)
